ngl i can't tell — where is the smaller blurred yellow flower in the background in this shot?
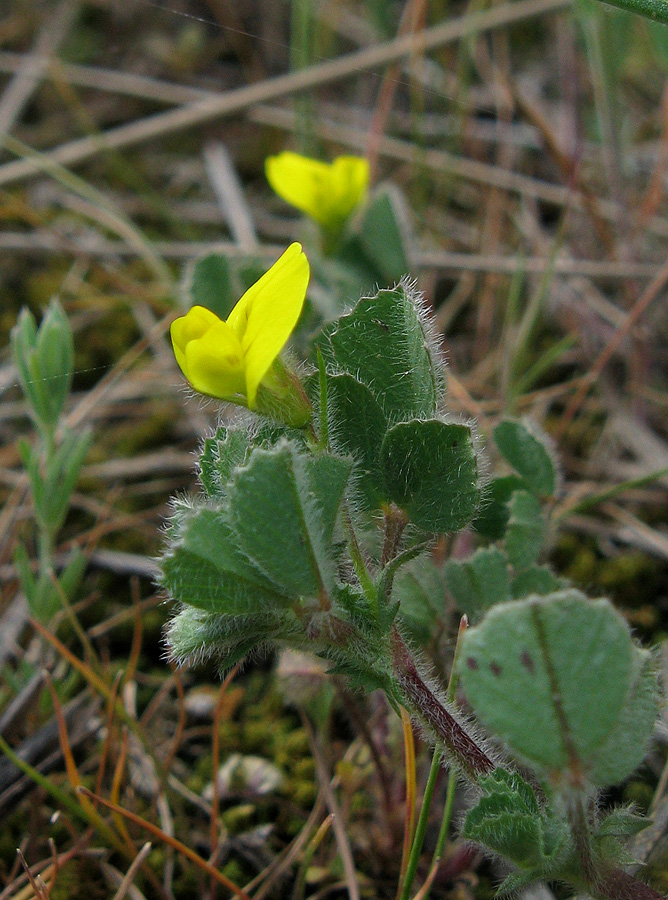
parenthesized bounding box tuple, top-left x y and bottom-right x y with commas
(265, 150, 369, 231)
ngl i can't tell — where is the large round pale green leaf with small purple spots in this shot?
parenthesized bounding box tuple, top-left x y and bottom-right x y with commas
(459, 590, 646, 784)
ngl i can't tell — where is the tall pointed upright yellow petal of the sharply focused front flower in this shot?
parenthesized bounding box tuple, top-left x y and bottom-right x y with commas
(237, 243, 310, 409)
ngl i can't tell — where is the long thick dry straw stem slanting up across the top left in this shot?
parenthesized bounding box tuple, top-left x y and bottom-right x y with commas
(0, 0, 570, 185)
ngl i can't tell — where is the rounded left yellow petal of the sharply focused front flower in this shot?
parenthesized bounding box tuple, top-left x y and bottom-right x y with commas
(171, 306, 246, 400)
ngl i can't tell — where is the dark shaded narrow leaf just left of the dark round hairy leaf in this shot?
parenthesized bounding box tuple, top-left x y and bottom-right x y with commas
(327, 375, 387, 509)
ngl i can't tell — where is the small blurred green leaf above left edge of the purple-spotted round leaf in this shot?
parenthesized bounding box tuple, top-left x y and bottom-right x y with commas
(443, 547, 510, 623)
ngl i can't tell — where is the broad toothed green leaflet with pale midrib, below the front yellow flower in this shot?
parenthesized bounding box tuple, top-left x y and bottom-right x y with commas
(228, 442, 352, 597)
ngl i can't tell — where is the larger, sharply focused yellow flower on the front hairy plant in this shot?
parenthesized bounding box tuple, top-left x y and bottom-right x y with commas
(171, 243, 310, 418)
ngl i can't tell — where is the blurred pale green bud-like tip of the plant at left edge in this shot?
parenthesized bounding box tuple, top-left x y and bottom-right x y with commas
(11, 299, 74, 426)
